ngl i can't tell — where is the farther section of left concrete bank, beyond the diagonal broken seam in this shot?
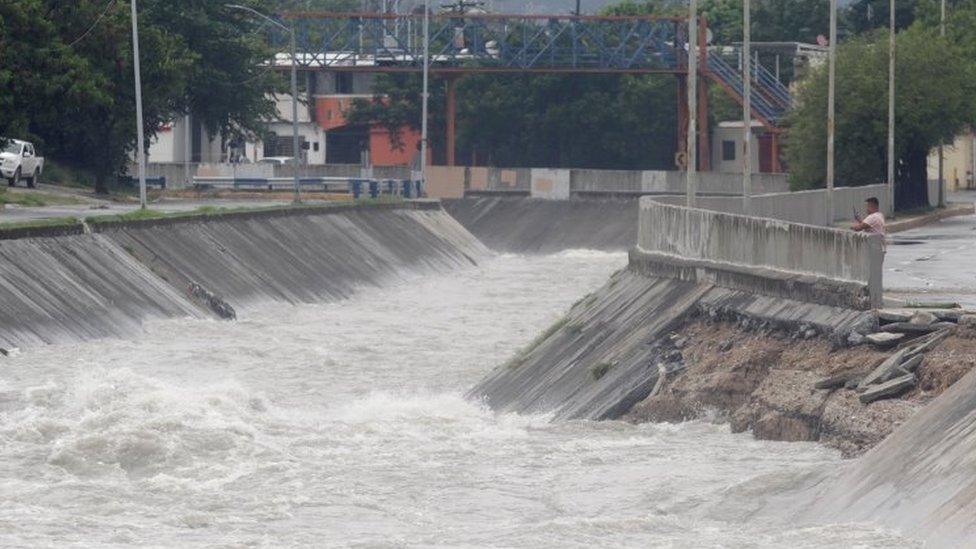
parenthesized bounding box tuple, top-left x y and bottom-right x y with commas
(100, 203, 488, 309)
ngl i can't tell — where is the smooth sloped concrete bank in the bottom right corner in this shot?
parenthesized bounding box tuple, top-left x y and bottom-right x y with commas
(805, 356, 976, 547)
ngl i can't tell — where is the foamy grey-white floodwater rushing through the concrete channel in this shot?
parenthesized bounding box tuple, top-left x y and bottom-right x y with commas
(0, 252, 905, 547)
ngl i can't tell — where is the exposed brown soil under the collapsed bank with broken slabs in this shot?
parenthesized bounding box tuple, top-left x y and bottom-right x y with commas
(625, 317, 976, 456)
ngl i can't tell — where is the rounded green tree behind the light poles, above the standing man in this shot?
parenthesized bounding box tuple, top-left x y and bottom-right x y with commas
(787, 25, 976, 209)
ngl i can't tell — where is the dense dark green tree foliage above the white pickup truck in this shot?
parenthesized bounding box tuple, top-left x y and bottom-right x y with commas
(0, 0, 278, 190)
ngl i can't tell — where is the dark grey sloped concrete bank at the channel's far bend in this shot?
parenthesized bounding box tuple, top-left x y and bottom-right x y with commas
(444, 197, 638, 254)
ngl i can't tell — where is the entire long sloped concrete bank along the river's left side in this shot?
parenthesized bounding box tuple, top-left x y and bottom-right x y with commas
(0, 203, 488, 348)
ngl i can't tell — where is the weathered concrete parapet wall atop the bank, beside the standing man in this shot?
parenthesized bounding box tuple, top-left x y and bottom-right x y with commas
(632, 197, 883, 309)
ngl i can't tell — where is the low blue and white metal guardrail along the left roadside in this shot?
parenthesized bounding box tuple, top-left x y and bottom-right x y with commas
(193, 177, 424, 200)
